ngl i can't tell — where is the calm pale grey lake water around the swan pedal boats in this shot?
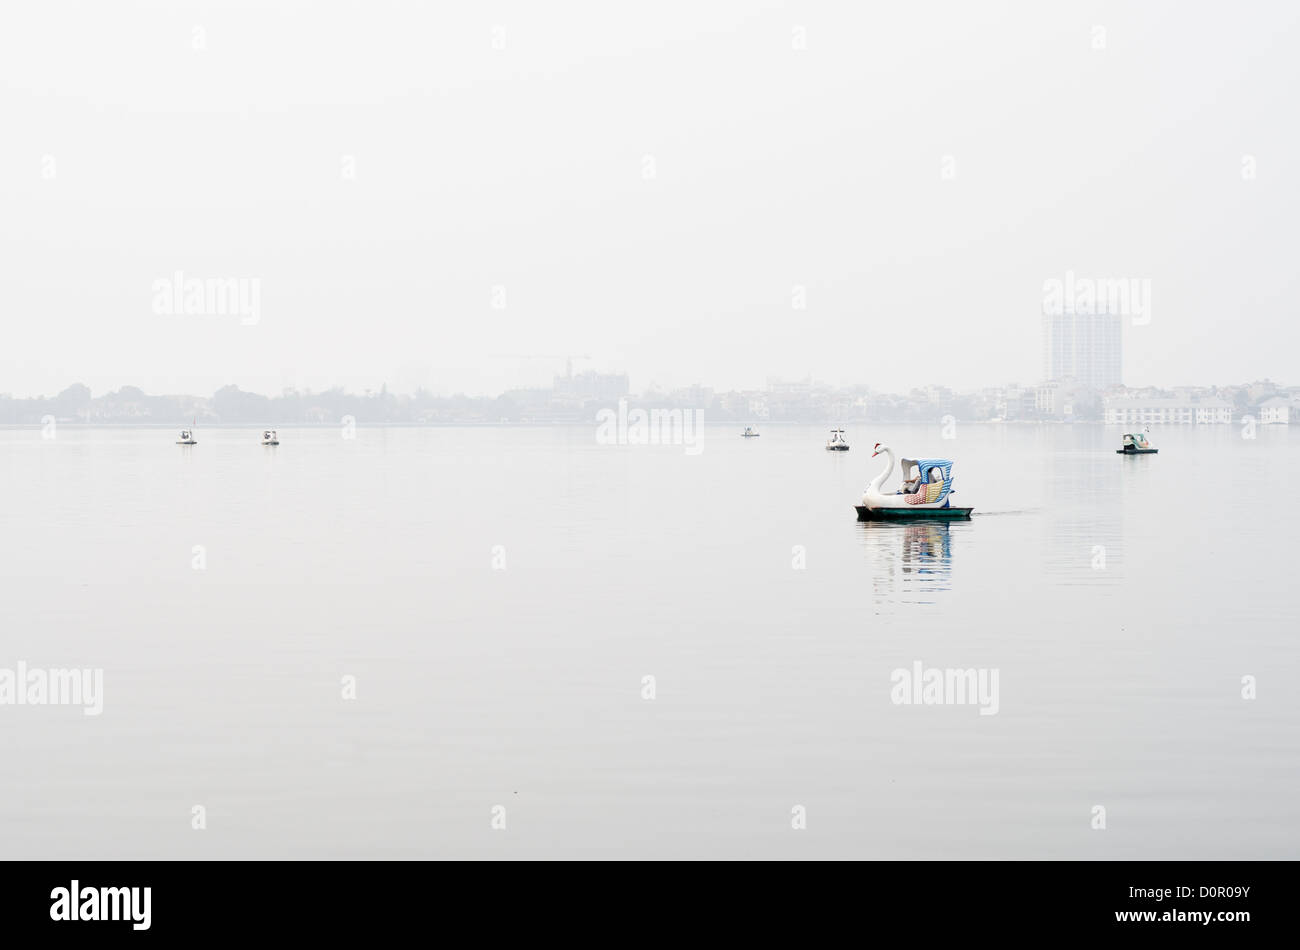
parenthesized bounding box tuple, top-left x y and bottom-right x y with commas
(0, 425, 1300, 859)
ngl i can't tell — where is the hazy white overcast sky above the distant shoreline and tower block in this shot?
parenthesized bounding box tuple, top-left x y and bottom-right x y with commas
(0, 0, 1300, 395)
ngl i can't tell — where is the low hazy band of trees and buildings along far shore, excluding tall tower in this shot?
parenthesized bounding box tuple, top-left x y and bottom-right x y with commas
(0, 372, 1300, 425)
